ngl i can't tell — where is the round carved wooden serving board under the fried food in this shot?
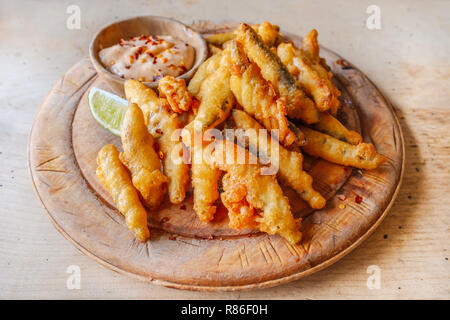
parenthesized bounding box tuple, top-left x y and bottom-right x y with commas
(28, 21, 404, 291)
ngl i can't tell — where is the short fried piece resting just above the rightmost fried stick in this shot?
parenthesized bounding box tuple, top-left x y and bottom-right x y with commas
(314, 112, 362, 144)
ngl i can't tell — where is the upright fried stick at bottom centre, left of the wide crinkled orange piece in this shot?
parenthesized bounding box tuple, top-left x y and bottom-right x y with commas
(191, 144, 221, 222)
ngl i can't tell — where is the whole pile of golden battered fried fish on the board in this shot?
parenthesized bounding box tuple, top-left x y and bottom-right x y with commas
(97, 22, 385, 244)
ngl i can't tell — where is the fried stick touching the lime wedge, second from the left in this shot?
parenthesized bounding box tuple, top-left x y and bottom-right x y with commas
(120, 103, 168, 210)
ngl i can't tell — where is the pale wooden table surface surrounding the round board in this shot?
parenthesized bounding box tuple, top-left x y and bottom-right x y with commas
(0, 0, 450, 299)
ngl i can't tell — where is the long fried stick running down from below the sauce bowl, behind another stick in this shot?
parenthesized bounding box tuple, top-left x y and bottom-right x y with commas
(125, 80, 189, 203)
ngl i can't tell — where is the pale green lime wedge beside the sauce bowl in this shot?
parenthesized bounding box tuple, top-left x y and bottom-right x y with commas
(88, 87, 128, 136)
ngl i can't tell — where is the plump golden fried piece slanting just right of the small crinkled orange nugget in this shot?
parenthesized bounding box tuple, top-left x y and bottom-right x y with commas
(182, 54, 234, 146)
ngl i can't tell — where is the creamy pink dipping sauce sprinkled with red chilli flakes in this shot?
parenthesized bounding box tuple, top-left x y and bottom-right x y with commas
(99, 35, 195, 81)
